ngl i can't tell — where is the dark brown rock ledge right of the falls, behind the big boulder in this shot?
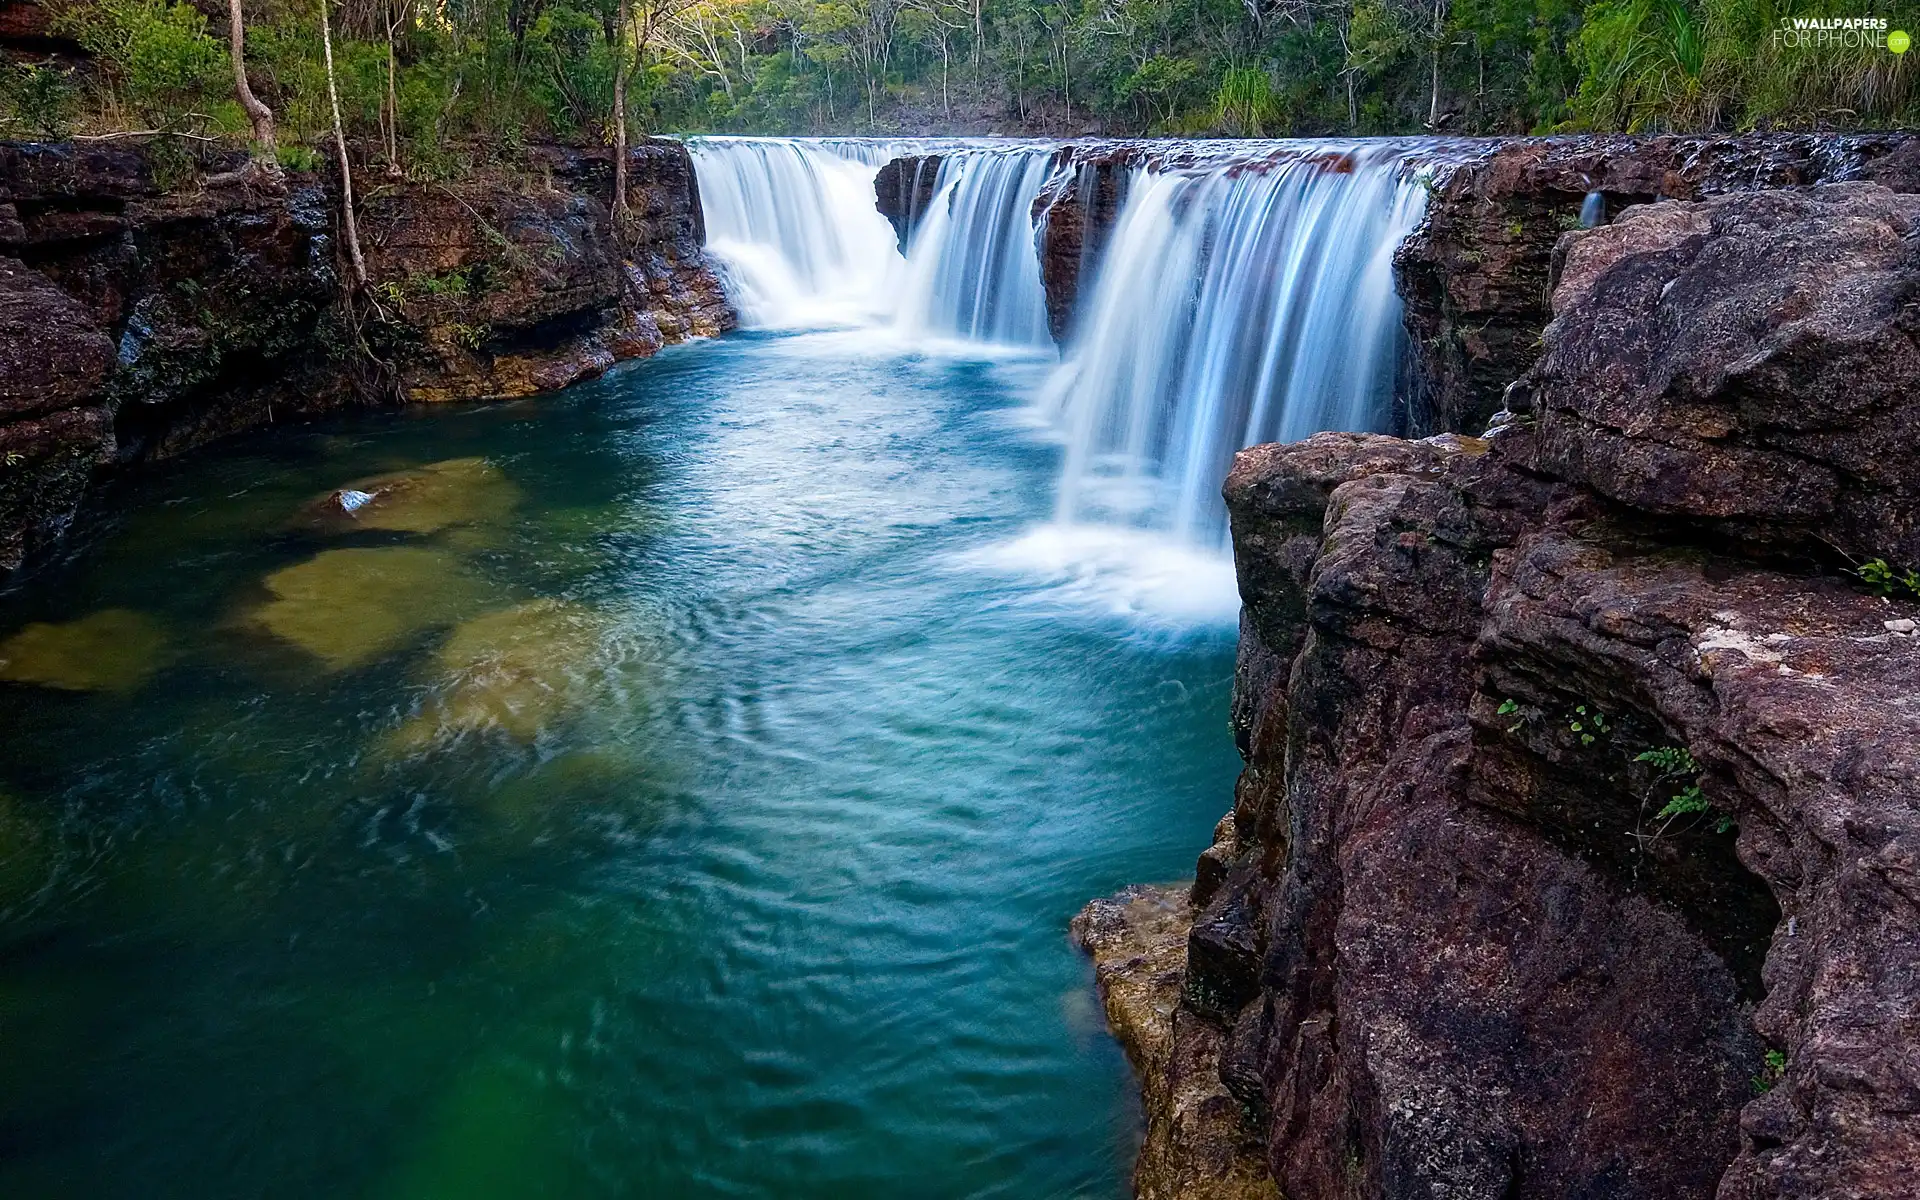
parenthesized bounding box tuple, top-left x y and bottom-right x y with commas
(1396, 134, 1920, 436)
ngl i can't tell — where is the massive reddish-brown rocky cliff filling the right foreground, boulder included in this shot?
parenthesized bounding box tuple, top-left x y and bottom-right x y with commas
(1079, 184, 1920, 1200)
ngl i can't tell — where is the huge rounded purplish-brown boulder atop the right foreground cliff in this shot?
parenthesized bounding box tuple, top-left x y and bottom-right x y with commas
(1515, 184, 1920, 564)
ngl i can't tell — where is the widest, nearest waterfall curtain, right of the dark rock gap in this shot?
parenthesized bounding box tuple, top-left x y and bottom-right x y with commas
(1044, 144, 1427, 545)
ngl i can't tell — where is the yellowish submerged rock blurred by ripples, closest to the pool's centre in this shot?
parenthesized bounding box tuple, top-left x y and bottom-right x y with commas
(384, 599, 605, 753)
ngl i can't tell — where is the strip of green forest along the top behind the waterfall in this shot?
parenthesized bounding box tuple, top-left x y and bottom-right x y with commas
(0, 0, 1920, 151)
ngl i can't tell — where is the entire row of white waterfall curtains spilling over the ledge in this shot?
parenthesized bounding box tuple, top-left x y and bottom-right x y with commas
(689, 138, 1434, 568)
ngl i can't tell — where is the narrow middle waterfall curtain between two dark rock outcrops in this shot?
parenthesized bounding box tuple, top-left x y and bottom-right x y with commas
(899, 146, 1056, 346)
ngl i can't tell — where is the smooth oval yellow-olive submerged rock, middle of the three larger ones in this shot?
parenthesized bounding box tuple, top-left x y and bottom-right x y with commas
(244, 545, 486, 670)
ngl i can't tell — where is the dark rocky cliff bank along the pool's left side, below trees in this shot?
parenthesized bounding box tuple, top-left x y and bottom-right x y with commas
(0, 142, 733, 582)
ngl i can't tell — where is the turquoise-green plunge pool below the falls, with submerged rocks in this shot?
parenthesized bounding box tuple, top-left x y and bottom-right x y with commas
(0, 334, 1236, 1200)
